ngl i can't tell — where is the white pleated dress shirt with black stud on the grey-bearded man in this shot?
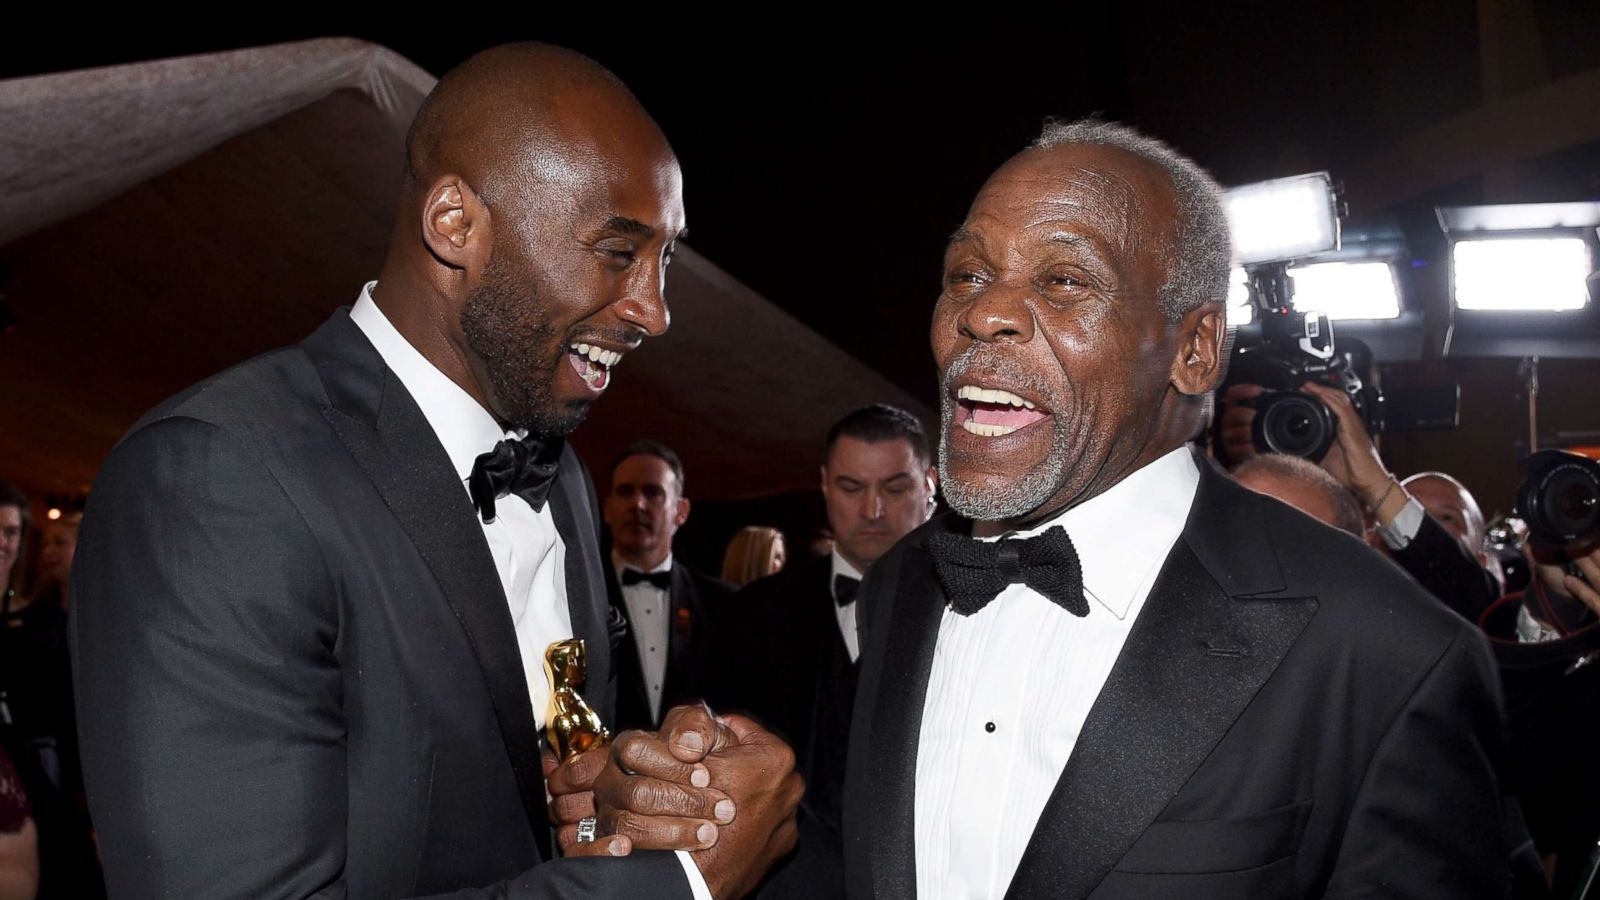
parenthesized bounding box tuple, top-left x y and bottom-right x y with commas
(915, 447, 1200, 900)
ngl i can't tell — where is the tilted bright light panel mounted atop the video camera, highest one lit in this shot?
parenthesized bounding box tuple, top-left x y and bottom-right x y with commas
(1224, 171, 1339, 266)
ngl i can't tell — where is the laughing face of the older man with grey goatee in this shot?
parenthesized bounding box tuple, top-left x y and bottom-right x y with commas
(931, 144, 1206, 524)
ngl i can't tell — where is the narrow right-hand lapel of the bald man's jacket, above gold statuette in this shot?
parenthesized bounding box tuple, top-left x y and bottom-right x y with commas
(550, 445, 616, 724)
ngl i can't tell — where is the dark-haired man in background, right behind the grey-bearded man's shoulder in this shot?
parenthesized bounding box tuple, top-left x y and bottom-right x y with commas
(712, 404, 938, 897)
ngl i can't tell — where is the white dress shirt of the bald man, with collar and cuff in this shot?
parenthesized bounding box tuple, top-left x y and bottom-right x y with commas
(350, 282, 710, 900)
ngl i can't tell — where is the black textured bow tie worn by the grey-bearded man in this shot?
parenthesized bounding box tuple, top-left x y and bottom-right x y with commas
(930, 525, 1090, 617)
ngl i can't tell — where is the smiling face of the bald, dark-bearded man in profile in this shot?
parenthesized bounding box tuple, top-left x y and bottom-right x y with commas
(461, 134, 683, 434)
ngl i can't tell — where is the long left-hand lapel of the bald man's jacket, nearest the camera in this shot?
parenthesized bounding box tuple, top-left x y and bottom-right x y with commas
(302, 311, 550, 858)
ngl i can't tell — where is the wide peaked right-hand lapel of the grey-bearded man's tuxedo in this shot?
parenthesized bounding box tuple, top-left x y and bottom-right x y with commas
(1006, 468, 1317, 900)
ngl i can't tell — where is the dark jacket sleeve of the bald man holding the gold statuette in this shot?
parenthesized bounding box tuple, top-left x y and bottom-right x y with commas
(70, 418, 690, 898)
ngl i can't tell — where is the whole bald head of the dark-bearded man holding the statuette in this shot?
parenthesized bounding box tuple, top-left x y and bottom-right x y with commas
(373, 43, 685, 436)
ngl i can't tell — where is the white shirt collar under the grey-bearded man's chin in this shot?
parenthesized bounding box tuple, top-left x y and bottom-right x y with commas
(989, 445, 1200, 618)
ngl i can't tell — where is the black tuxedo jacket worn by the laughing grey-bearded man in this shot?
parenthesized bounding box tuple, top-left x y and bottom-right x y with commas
(845, 460, 1509, 900)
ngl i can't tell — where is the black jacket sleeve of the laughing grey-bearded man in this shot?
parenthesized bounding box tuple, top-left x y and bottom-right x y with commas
(1326, 625, 1510, 898)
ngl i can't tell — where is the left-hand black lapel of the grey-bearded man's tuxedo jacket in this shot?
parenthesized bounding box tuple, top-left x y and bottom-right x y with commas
(856, 531, 947, 898)
